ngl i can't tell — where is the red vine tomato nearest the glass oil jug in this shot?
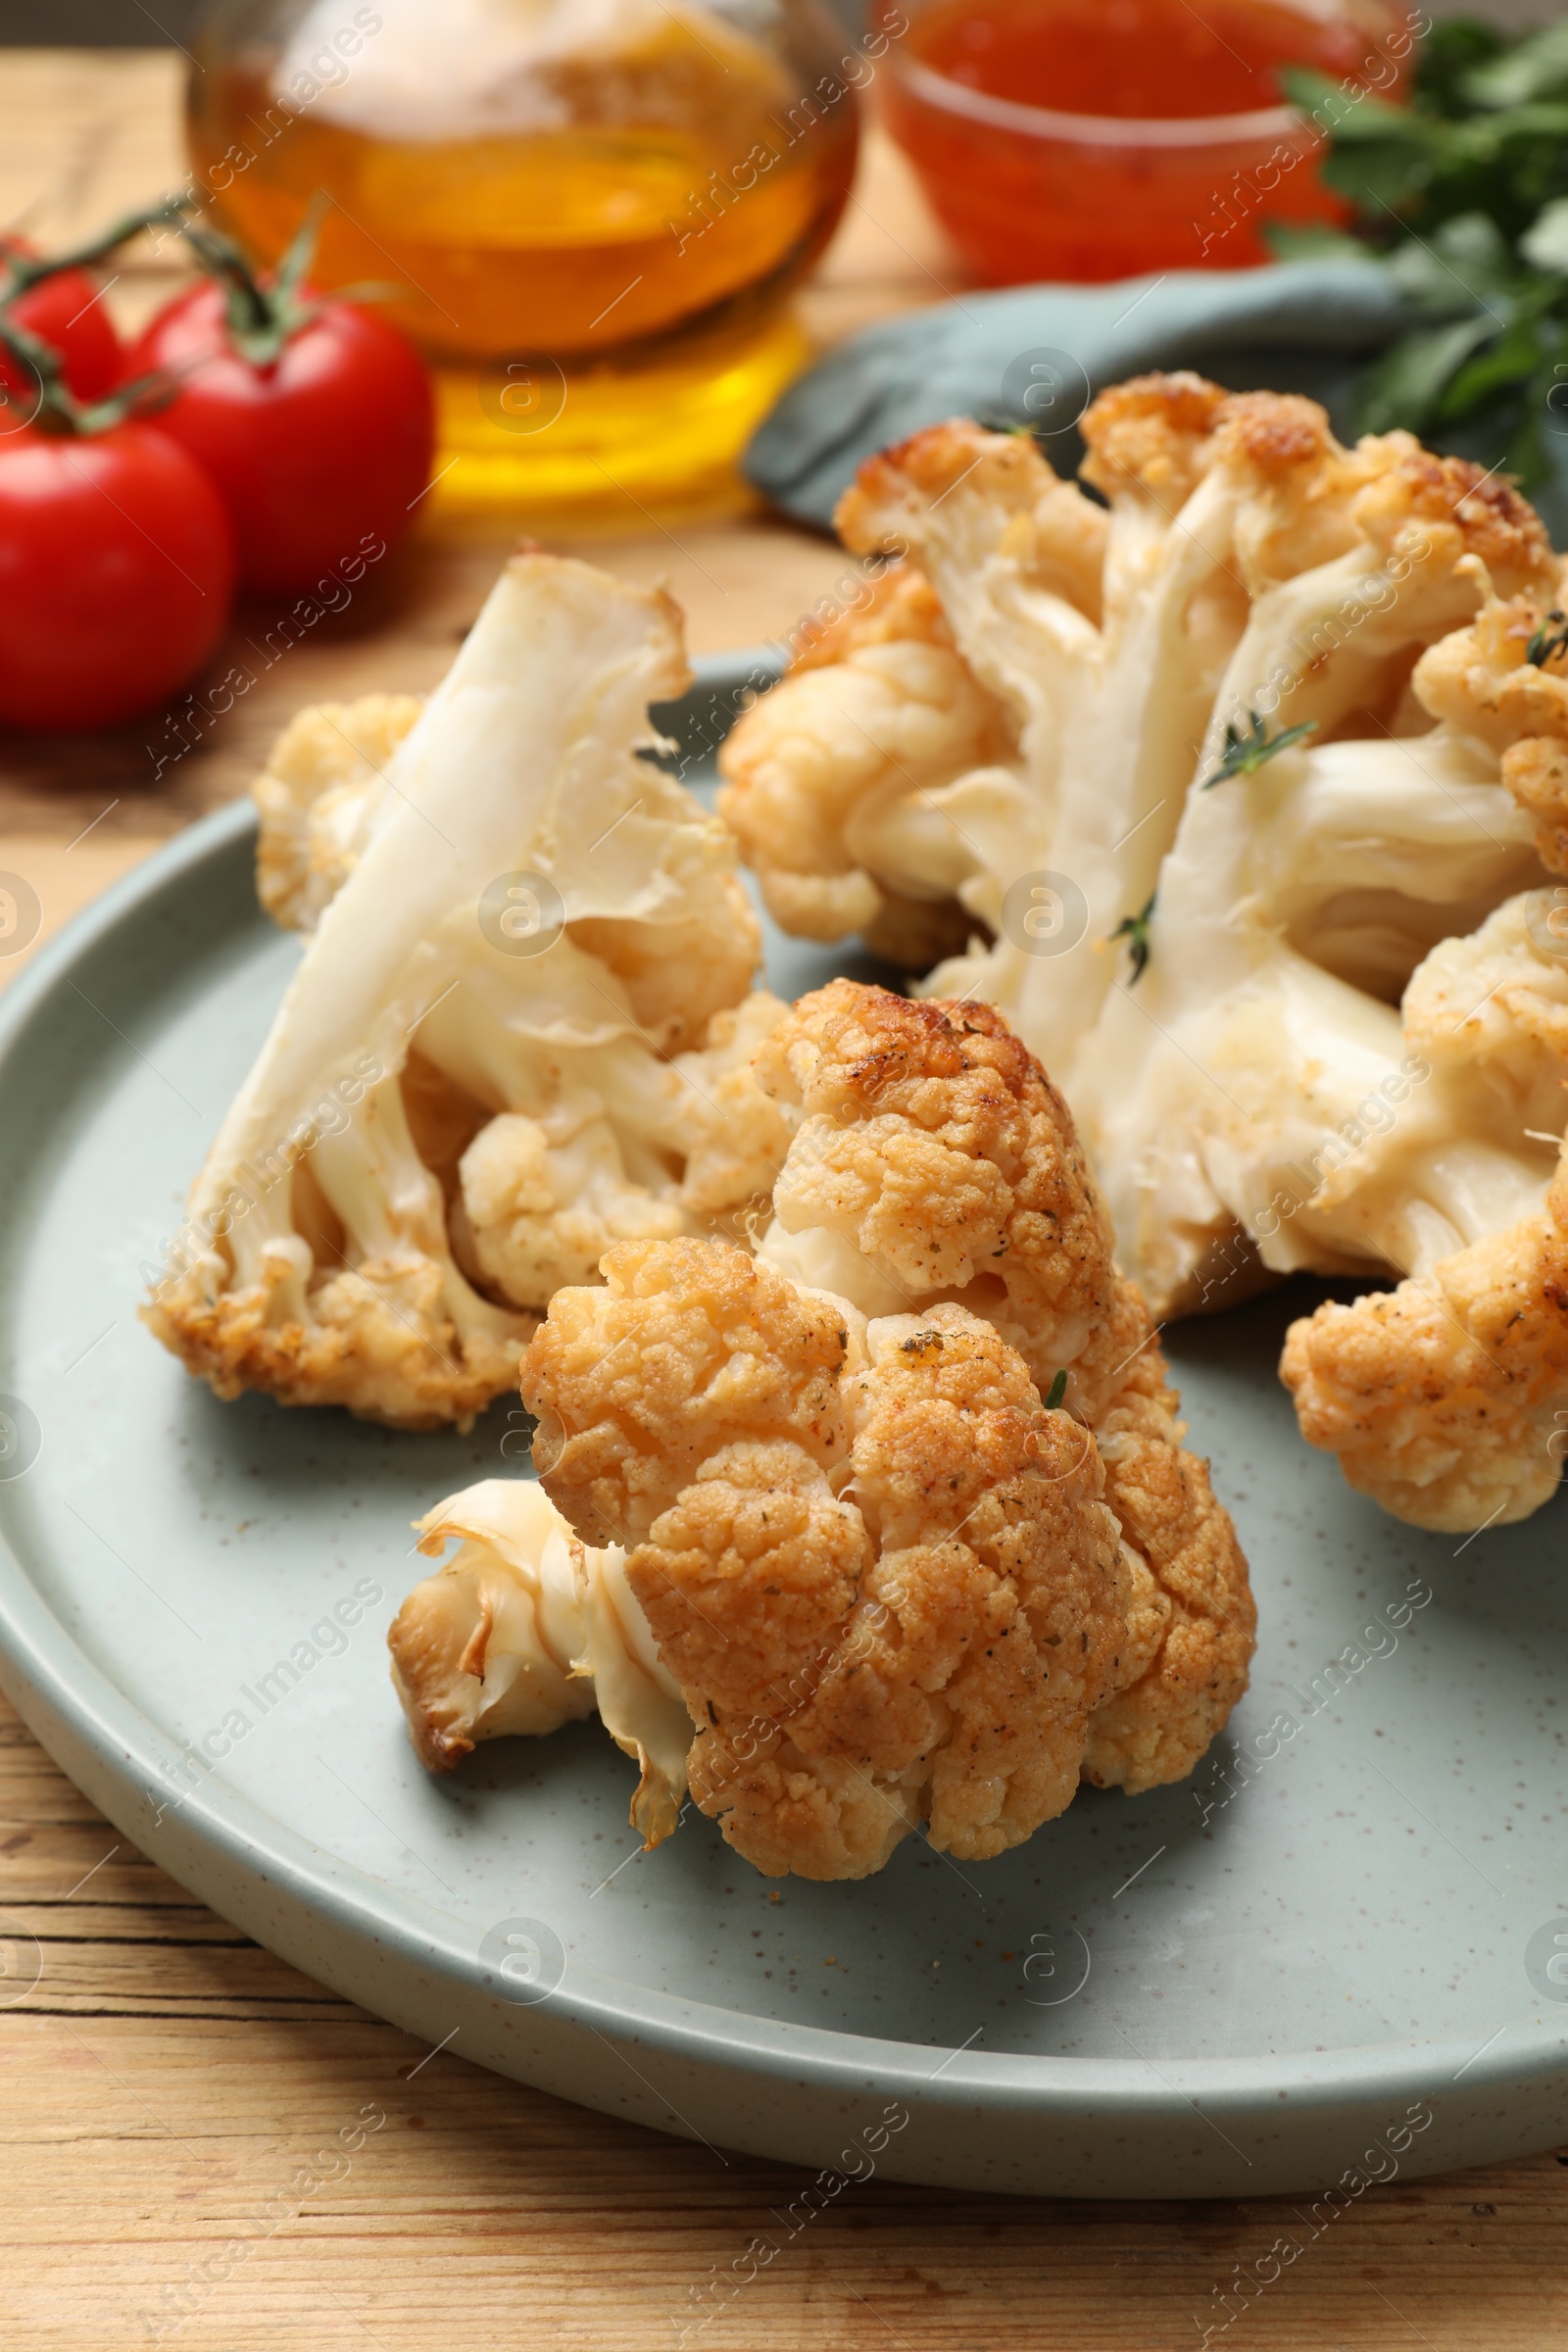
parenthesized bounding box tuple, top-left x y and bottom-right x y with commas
(127, 280, 435, 595)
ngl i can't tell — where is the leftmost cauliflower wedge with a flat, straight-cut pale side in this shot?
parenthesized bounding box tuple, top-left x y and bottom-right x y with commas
(143, 551, 788, 1428)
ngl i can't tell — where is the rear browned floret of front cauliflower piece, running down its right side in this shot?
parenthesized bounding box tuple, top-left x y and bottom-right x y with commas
(757, 981, 1255, 1792)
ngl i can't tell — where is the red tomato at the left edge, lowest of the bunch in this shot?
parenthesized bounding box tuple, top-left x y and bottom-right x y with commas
(0, 423, 235, 731)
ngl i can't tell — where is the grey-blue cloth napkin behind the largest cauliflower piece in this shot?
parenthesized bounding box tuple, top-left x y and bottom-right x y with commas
(745, 261, 1419, 529)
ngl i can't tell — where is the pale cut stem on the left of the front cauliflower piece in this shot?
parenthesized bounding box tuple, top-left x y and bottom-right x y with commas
(388, 1480, 691, 1846)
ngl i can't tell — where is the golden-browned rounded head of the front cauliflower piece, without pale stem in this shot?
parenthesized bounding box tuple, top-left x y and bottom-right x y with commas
(395, 981, 1255, 1880)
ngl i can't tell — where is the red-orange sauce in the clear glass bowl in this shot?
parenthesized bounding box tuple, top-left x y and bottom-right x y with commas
(884, 0, 1413, 284)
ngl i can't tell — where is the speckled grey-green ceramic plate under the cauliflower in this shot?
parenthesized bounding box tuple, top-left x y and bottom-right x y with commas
(0, 663, 1568, 2197)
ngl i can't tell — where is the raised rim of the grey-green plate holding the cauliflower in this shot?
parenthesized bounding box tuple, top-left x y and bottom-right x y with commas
(0, 654, 1568, 2197)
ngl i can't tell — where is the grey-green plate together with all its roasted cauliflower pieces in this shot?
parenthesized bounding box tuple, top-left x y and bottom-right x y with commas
(0, 374, 1568, 2194)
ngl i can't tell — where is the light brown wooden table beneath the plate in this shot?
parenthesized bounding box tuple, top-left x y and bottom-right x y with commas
(0, 52, 1568, 2352)
